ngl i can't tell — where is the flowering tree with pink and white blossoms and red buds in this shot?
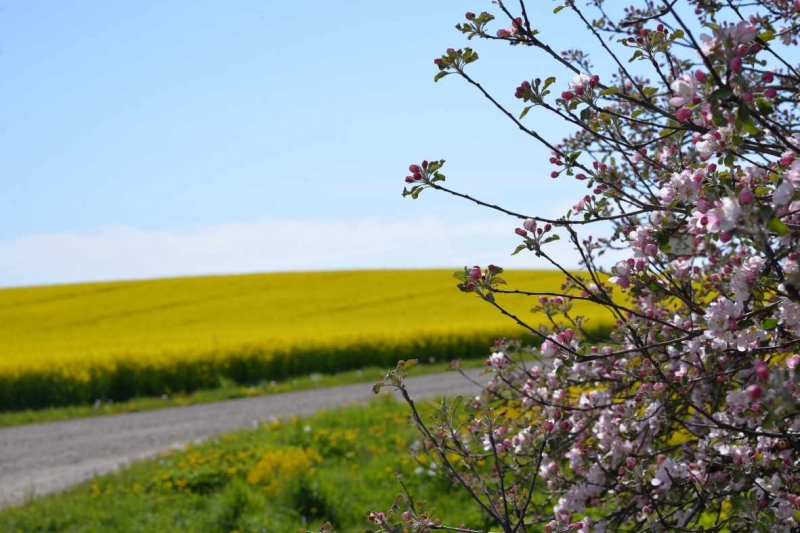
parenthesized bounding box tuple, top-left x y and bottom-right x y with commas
(370, 0, 800, 533)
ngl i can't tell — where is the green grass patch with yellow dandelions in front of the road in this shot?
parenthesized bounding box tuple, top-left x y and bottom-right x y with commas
(0, 398, 494, 533)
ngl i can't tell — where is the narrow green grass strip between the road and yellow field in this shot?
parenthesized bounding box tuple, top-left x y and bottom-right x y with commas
(0, 359, 484, 428)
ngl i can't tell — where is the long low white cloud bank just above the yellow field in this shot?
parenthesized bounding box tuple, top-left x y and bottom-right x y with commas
(0, 216, 616, 286)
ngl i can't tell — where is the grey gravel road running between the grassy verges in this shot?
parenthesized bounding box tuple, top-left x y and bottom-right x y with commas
(0, 369, 485, 508)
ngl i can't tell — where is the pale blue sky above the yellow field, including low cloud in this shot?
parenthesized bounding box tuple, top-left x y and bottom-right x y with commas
(0, 0, 582, 286)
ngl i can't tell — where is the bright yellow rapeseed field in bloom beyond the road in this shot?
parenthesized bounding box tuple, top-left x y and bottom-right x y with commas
(0, 270, 612, 410)
